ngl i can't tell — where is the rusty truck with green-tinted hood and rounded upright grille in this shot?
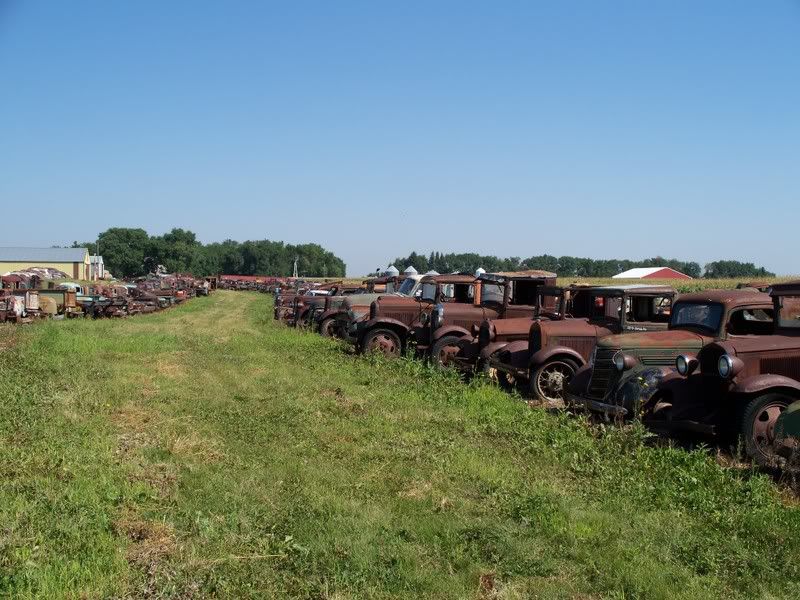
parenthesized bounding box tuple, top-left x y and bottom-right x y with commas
(567, 289, 773, 420)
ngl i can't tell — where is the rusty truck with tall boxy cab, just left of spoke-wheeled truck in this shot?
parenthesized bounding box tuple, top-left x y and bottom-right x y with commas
(424, 270, 556, 372)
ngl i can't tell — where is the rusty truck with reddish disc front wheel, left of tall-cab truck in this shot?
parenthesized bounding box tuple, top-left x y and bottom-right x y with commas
(356, 274, 481, 357)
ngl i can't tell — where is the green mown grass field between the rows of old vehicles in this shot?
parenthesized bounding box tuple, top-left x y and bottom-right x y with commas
(0, 292, 800, 599)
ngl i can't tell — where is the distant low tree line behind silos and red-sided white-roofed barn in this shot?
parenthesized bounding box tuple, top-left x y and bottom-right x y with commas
(392, 252, 774, 279)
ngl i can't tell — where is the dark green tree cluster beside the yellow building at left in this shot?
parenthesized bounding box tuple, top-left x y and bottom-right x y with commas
(72, 227, 345, 278)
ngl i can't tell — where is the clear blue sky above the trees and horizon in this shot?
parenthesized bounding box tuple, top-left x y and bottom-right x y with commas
(0, 0, 800, 274)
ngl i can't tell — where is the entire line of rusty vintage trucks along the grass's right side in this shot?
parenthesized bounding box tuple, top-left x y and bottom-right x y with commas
(272, 271, 800, 474)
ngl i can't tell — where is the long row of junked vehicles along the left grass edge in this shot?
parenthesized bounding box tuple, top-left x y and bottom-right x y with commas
(0, 273, 209, 323)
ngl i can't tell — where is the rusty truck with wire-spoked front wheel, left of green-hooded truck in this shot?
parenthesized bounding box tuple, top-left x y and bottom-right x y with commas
(487, 285, 676, 403)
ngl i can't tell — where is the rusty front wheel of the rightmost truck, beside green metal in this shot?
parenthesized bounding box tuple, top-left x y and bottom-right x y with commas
(739, 393, 794, 467)
